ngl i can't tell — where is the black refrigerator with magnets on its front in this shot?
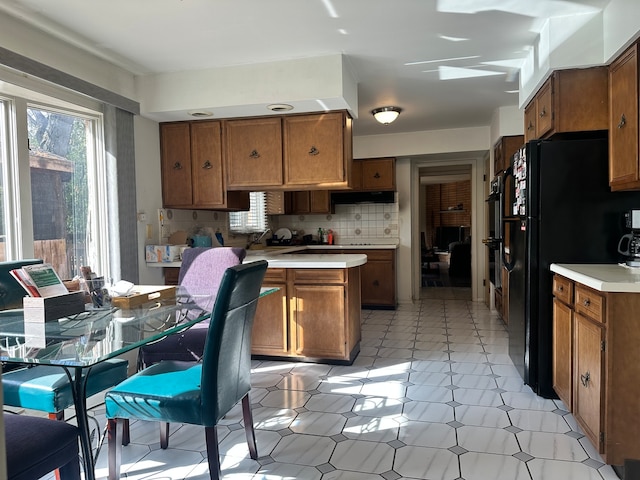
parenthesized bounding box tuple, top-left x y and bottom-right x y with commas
(501, 138, 640, 398)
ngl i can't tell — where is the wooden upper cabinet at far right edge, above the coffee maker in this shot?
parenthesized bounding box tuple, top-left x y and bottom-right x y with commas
(609, 44, 640, 191)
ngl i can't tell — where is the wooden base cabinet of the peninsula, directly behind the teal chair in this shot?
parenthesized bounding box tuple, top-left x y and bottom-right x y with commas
(251, 267, 361, 364)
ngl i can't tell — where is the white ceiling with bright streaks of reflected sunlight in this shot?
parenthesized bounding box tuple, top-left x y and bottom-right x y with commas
(0, 0, 609, 135)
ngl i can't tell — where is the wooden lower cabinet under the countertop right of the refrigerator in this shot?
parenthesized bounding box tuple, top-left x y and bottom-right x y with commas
(553, 274, 640, 466)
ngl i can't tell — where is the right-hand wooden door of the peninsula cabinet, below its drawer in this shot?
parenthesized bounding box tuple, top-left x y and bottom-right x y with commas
(291, 285, 349, 359)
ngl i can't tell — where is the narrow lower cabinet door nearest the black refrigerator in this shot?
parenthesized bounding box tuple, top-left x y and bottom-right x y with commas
(552, 298, 573, 411)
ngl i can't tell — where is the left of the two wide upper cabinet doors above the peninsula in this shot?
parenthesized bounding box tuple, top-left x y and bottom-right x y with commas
(224, 117, 283, 190)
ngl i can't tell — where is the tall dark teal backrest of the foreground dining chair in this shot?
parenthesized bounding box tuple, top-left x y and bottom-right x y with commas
(201, 260, 268, 425)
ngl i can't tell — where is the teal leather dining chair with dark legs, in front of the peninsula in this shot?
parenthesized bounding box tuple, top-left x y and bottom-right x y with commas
(105, 260, 267, 480)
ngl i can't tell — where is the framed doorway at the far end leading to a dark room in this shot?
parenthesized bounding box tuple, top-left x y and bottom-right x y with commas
(411, 151, 488, 301)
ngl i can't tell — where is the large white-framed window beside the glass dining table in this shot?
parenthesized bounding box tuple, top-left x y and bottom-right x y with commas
(0, 93, 109, 278)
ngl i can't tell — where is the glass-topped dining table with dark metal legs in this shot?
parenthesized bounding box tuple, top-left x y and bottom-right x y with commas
(0, 287, 218, 480)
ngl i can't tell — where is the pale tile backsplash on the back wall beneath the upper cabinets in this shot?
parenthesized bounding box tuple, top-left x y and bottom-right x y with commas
(156, 203, 398, 246)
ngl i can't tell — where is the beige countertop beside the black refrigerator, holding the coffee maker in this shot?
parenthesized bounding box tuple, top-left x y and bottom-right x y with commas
(551, 263, 640, 293)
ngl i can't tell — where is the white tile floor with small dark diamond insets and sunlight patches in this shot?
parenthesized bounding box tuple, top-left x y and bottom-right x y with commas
(71, 288, 618, 480)
